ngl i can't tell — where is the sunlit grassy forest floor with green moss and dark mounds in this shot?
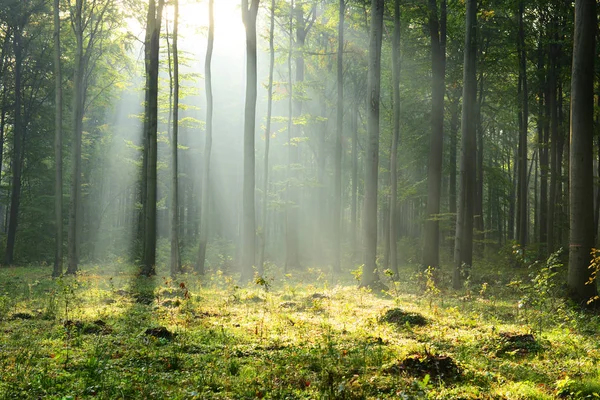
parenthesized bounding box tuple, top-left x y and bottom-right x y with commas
(0, 258, 600, 399)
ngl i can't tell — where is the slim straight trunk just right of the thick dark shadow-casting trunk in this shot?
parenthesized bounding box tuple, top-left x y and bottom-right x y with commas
(171, 0, 181, 276)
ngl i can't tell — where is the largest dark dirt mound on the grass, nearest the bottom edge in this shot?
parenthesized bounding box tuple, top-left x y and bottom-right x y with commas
(384, 353, 461, 381)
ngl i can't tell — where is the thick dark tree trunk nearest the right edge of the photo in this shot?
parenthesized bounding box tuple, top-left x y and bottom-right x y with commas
(568, 0, 598, 303)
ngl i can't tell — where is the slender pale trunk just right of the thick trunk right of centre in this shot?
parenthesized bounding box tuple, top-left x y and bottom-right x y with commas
(389, 0, 400, 279)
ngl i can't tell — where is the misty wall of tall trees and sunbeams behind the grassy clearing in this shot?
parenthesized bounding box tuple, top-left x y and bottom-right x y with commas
(0, 0, 600, 304)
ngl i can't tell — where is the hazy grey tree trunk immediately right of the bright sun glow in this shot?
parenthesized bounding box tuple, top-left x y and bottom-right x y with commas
(242, 0, 260, 281)
